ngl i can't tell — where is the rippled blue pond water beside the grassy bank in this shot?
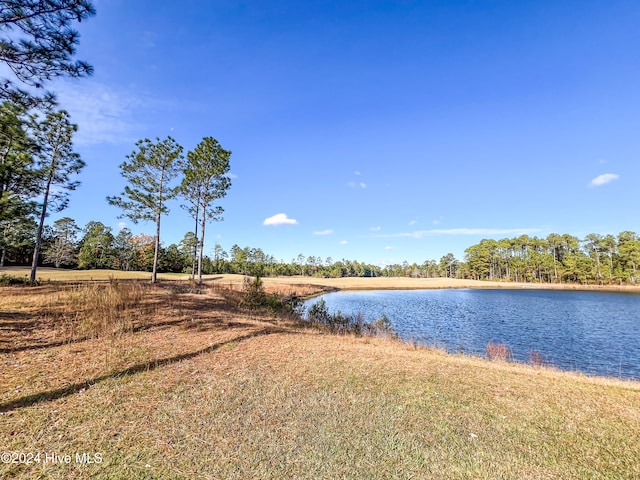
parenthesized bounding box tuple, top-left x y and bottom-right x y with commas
(307, 289, 640, 380)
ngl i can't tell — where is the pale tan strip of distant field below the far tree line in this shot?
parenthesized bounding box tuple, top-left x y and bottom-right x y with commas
(5, 267, 640, 292)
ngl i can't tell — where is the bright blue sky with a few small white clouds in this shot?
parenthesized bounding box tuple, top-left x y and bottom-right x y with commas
(35, 0, 640, 265)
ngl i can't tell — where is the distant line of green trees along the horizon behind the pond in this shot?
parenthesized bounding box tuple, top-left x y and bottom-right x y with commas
(0, 221, 640, 285)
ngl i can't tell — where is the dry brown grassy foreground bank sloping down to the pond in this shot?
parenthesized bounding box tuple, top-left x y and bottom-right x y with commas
(0, 279, 640, 479)
